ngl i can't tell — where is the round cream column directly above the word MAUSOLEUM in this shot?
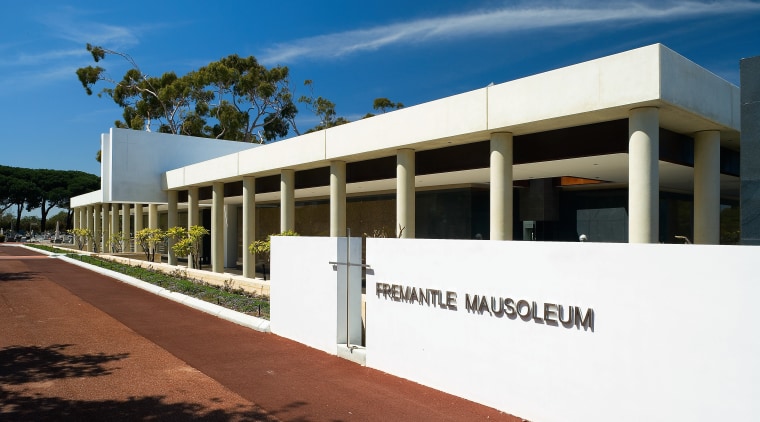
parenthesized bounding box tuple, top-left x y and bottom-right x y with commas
(490, 132, 514, 240)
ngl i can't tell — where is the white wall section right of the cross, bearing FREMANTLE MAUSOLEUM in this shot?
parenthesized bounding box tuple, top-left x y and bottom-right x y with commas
(366, 239, 760, 421)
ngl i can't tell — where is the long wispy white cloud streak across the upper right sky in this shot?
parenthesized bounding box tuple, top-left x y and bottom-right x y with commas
(259, 0, 760, 64)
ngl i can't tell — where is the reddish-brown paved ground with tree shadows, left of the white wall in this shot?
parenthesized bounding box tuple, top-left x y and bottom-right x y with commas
(0, 245, 522, 421)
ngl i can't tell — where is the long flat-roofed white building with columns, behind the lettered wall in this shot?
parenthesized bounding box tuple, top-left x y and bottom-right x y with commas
(71, 45, 739, 275)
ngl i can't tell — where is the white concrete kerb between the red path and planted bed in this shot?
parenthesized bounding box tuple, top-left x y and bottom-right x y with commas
(21, 246, 271, 333)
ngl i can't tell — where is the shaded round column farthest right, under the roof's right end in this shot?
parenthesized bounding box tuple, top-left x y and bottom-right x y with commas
(694, 130, 720, 245)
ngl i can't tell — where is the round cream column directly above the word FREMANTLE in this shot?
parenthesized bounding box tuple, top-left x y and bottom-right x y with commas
(396, 149, 416, 239)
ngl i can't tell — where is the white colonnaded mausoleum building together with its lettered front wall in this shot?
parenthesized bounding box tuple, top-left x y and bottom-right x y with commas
(71, 44, 760, 421)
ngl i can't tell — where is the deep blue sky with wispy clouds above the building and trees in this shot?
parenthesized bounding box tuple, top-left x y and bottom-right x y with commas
(0, 0, 760, 178)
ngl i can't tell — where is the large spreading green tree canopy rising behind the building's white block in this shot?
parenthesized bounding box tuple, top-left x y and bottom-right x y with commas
(76, 44, 298, 143)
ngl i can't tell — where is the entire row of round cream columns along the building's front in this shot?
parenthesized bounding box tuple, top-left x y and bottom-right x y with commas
(74, 107, 720, 277)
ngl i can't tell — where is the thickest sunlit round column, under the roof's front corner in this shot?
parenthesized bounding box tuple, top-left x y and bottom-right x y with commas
(628, 107, 660, 243)
